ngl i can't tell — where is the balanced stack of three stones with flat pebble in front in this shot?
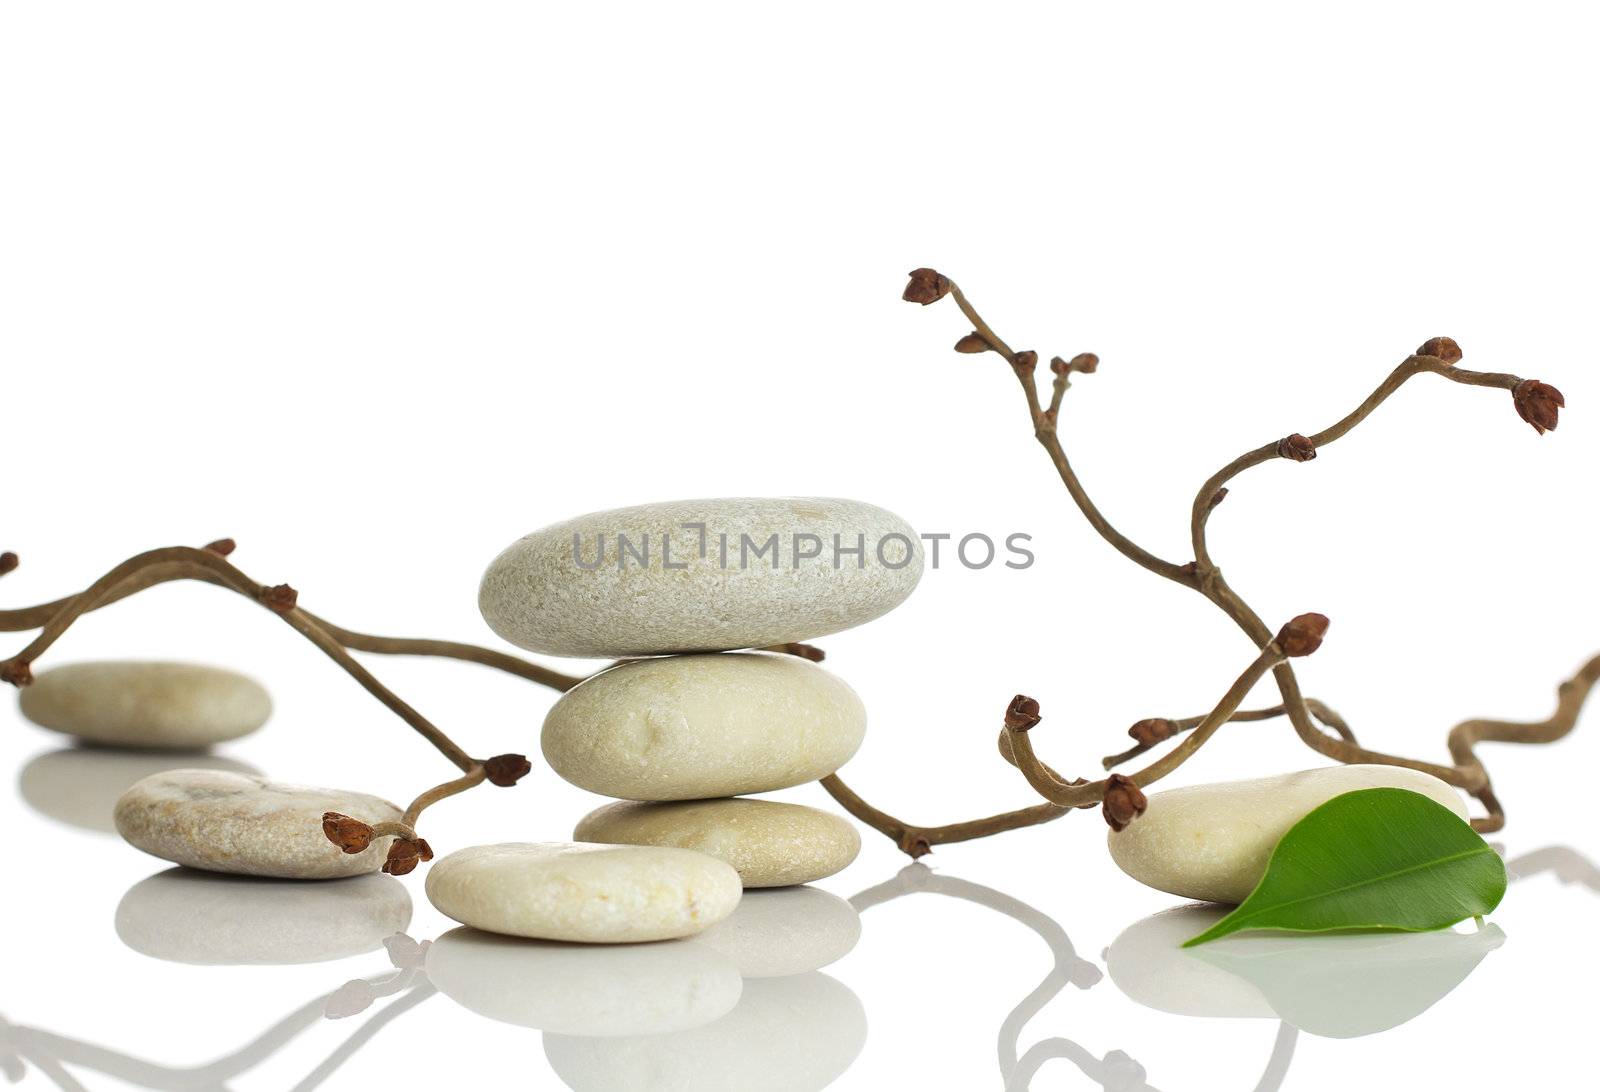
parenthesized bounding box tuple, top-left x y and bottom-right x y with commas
(427, 498, 922, 941)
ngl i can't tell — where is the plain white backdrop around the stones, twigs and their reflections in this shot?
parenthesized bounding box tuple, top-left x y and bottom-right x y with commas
(0, 3, 1600, 1089)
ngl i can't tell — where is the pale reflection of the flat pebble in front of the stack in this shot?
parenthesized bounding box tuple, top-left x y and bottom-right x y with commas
(426, 929, 744, 1038)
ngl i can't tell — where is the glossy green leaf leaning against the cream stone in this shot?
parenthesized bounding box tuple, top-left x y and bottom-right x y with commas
(1184, 788, 1506, 948)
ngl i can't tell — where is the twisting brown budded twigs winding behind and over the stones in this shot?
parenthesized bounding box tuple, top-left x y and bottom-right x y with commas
(0, 269, 1600, 871)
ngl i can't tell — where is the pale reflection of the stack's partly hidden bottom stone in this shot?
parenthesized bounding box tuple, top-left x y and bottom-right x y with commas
(696, 887, 861, 978)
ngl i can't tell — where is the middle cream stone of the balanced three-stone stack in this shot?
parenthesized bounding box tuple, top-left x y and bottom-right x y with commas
(541, 652, 867, 801)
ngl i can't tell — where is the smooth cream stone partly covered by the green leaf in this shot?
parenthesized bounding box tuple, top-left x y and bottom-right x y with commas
(1109, 755, 1467, 903)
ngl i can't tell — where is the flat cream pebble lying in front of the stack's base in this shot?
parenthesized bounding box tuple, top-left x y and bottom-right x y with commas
(427, 842, 741, 945)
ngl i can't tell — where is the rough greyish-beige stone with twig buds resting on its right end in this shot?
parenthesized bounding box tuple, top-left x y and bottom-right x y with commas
(112, 770, 400, 879)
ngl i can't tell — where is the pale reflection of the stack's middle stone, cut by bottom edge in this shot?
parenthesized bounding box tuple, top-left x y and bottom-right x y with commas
(544, 972, 876, 1092)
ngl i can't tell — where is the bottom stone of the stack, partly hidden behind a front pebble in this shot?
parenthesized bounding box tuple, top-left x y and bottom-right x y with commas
(573, 799, 861, 887)
